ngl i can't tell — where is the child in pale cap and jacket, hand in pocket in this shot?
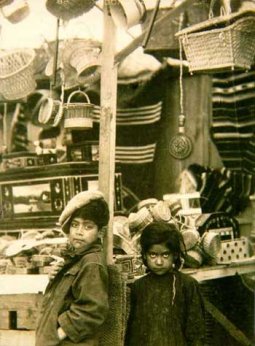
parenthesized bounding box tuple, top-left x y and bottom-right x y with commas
(36, 191, 109, 346)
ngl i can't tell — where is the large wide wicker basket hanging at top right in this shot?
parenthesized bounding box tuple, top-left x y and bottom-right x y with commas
(176, 11, 255, 73)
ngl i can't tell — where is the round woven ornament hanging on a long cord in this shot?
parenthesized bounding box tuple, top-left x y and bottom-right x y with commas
(169, 16, 193, 160)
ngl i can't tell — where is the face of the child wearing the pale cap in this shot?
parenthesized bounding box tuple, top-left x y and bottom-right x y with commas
(69, 217, 98, 249)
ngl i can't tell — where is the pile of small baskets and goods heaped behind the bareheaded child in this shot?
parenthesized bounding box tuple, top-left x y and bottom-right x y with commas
(113, 193, 253, 277)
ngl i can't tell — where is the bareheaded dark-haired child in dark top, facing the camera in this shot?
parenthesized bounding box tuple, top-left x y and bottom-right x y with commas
(126, 222, 205, 346)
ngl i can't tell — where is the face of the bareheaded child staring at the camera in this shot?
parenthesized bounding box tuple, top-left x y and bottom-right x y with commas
(146, 243, 174, 275)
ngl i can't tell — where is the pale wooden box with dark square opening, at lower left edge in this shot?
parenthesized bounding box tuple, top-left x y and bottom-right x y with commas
(0, 293, 42, 330)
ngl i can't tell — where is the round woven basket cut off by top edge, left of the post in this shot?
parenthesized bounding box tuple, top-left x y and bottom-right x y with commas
(46, 0, 95, 20)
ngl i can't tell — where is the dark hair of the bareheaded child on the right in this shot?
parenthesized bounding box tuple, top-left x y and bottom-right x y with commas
(140, 221, 185, 269)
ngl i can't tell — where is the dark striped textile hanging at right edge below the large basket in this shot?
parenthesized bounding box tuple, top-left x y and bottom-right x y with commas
(211, 70, 255, 174)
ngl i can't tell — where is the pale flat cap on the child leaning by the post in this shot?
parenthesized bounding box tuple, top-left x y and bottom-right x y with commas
(58, 191, 105, 231)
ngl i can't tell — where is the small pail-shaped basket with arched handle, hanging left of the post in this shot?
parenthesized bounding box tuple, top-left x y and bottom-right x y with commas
(64, 90, 94, 130)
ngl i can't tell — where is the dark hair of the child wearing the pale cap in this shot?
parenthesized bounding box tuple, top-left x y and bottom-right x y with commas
(69, 199, 109, 229)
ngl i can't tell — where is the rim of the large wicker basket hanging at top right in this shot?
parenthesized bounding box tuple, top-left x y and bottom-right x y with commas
(175, 10, 255, 37)
